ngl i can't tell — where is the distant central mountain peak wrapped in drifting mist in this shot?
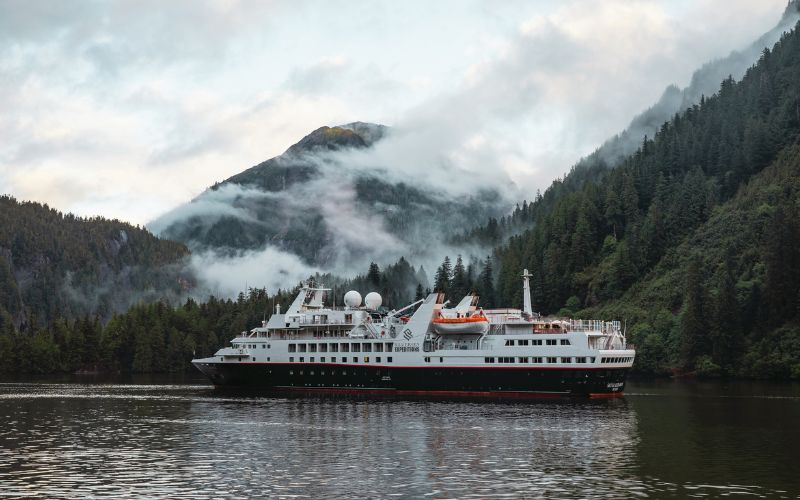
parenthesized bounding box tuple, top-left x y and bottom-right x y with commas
(149, 122, 508, 267)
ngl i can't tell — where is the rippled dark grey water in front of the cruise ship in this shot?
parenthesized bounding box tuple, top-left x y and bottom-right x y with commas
(0, 379, 800, 498)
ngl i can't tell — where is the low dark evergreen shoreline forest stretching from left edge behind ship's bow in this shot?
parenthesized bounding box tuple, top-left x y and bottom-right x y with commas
(0, 259, 430, 373)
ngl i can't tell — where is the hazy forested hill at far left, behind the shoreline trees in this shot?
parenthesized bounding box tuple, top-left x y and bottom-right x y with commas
(0, 196, 191, 331)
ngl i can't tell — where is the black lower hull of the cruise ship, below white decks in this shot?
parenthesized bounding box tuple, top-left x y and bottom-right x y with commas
(192, 363, 628, 399)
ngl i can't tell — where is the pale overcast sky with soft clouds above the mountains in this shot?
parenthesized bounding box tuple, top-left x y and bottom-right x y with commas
(0, 0, 786, 223)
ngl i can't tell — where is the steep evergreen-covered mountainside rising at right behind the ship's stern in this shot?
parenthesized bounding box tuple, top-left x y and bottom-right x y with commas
(478, 20, 800, 376)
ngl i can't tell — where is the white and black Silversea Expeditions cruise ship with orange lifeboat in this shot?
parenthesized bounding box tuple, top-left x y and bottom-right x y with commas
(192, 270, 636, 399)
